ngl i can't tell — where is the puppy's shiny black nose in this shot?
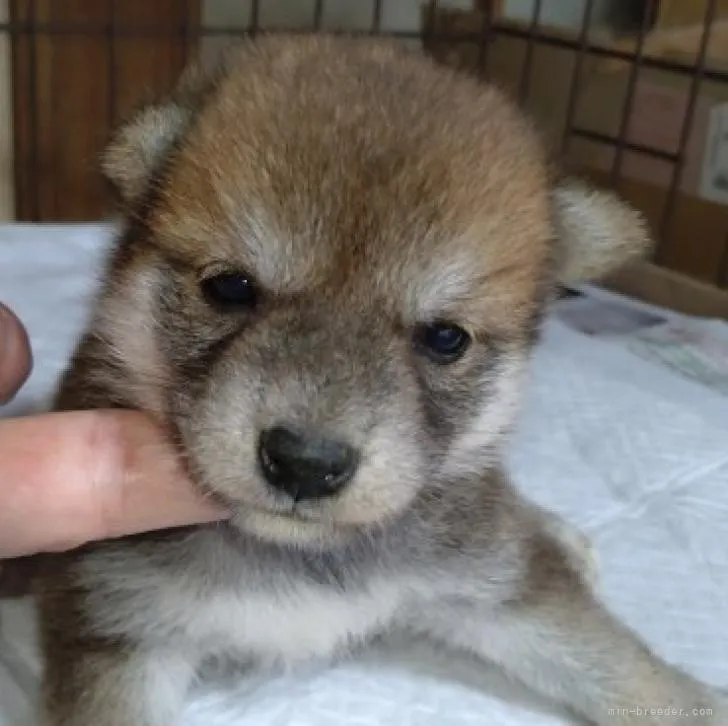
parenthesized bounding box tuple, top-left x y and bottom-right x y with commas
(258, 426, 358, 501)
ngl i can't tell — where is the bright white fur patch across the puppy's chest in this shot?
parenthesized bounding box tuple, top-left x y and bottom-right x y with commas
(178, 585, 400, 663)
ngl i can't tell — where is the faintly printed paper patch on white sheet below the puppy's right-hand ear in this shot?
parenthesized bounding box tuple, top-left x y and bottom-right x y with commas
(555, 292, 728, 396)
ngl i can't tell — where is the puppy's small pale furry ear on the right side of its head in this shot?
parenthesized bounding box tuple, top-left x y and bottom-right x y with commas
(553, 179, 652, 285)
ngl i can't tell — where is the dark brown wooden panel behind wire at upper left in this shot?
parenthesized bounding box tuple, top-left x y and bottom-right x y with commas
(9, 0, 200, 221)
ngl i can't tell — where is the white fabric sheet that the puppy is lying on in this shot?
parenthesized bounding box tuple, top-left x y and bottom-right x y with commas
(0, 225, 728, 726)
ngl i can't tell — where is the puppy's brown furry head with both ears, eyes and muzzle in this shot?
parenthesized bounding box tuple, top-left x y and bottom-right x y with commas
(88, 37, 644, 543)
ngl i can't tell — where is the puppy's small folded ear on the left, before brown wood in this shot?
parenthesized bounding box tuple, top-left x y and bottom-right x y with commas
(101, 101, 190, 205)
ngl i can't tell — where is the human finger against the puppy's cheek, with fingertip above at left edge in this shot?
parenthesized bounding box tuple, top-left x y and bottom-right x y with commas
(0, 305, 226, 559)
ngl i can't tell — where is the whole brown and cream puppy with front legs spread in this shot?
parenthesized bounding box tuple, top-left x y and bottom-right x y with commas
(41, 36, 728, 726)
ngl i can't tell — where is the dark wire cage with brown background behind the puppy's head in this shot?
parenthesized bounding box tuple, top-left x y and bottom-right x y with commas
(0, 0, 728, 310)
